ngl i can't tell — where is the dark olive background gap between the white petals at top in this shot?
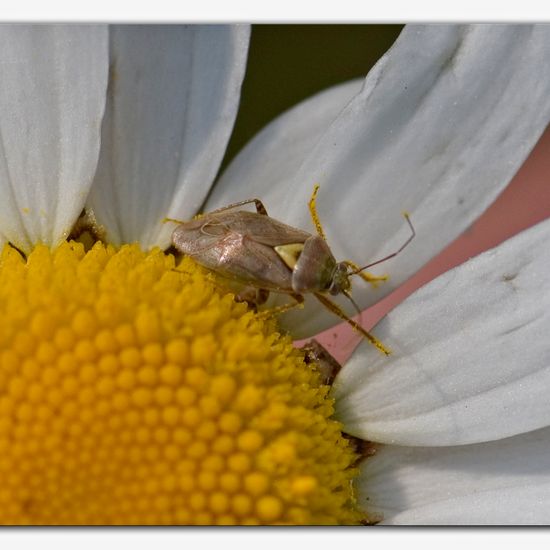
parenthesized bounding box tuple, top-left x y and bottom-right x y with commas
(222, 25, 403, 169)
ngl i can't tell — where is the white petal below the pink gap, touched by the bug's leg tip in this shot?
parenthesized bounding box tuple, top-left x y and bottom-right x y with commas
(334, 220, 550, 446)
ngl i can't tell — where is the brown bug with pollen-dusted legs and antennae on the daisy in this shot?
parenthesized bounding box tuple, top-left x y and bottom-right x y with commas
(164, 185, 415, 355)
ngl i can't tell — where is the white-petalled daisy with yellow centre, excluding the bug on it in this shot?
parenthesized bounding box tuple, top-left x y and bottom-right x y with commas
(0, 25, 550, 524)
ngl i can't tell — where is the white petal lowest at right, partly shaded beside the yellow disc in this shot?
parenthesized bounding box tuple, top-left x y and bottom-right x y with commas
(357, 428, 550, 525)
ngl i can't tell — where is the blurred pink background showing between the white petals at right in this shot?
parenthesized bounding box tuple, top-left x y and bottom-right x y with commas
(302, 128, 550, 364)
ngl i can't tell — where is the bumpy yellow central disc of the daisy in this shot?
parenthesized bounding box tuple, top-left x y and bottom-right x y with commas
(0, 242, 364, 525)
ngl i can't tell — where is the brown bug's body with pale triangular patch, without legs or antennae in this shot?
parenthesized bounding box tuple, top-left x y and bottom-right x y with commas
(172, 210, 347, 294)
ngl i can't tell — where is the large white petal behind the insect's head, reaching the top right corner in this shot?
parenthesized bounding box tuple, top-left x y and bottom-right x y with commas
(210, 25, 550, 337)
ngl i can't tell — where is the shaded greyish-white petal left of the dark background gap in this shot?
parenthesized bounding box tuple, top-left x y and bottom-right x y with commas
(89, 25, 249, 248)
